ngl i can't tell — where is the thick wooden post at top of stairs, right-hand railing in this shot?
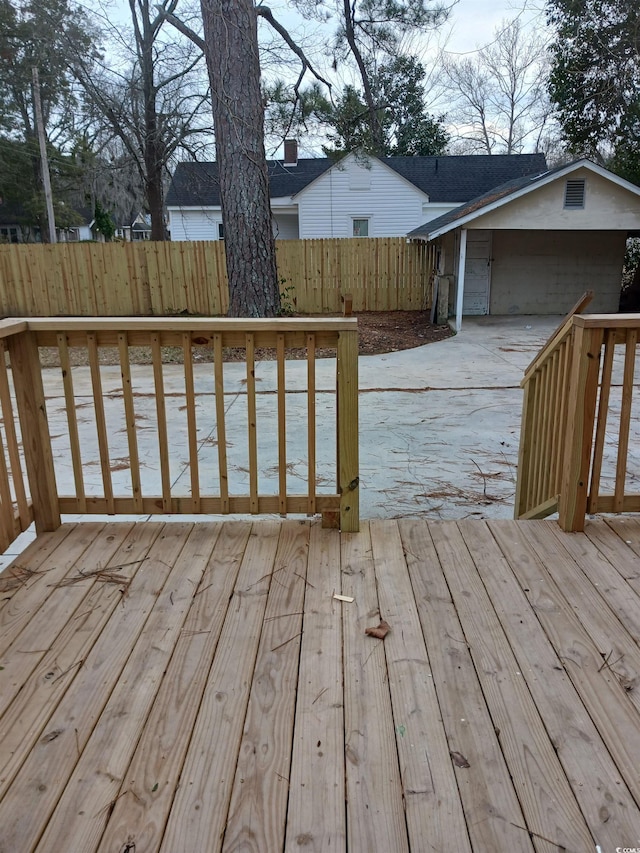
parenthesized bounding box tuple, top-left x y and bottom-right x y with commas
(558, 324, 603, 532)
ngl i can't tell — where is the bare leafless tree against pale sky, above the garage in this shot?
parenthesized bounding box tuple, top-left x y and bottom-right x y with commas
(443, 18, 552, 154)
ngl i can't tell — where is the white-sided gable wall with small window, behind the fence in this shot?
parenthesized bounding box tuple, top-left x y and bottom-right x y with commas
(294, 156, 428, 239)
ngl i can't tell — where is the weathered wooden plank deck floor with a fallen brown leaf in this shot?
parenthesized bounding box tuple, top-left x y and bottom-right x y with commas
(0, 517, 640, 853)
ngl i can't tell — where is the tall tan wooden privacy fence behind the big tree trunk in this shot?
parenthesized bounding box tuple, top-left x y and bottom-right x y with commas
(0, 237, 435, 317)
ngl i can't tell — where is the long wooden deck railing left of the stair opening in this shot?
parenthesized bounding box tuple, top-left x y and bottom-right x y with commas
(0, 318, 359, 531)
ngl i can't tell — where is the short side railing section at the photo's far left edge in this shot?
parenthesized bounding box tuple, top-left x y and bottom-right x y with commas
(0, 323, 33, 552)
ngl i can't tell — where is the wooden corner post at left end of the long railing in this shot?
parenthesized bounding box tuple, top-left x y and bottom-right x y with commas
(8, 331, 60, 533)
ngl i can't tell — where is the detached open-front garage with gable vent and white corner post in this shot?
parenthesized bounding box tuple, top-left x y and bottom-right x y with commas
(408, 159, 640, 328)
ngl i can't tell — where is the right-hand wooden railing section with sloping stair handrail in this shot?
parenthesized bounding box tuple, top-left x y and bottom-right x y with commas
(515, 314, 640, 531)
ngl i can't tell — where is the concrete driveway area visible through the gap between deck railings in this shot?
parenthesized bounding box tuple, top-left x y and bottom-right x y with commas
(360, 317, 562, 519)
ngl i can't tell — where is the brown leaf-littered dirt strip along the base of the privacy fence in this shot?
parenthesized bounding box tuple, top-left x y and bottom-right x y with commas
(40, 311, 453, 367)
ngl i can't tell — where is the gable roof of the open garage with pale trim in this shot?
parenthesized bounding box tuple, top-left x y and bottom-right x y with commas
(407, 158, 640, 240)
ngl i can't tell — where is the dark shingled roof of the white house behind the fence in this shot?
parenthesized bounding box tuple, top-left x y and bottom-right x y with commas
(166, 154, 547, 207)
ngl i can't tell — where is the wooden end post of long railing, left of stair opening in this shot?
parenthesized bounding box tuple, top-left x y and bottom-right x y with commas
(337, 331, 360, 533)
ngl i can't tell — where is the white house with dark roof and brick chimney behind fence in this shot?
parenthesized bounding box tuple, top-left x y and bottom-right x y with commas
(167, 140, 546, 240)
